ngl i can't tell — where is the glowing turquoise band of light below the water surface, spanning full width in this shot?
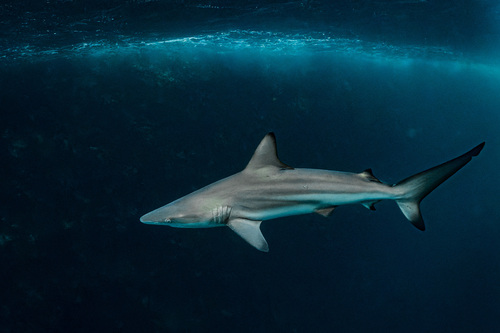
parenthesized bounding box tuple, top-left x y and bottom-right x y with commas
(0, 30, 500, 79)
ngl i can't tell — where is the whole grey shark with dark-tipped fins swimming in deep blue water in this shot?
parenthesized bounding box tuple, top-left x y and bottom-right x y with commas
(140, 133, 484, 252)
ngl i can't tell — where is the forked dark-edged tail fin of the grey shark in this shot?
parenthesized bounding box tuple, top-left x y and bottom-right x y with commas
(394, 142, 484, 231)
